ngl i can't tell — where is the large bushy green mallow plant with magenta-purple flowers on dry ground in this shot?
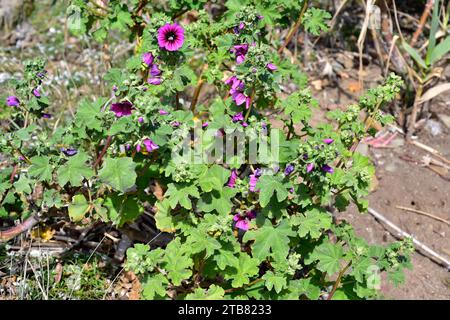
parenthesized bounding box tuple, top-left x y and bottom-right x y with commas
(0, 1, 412, 300)
